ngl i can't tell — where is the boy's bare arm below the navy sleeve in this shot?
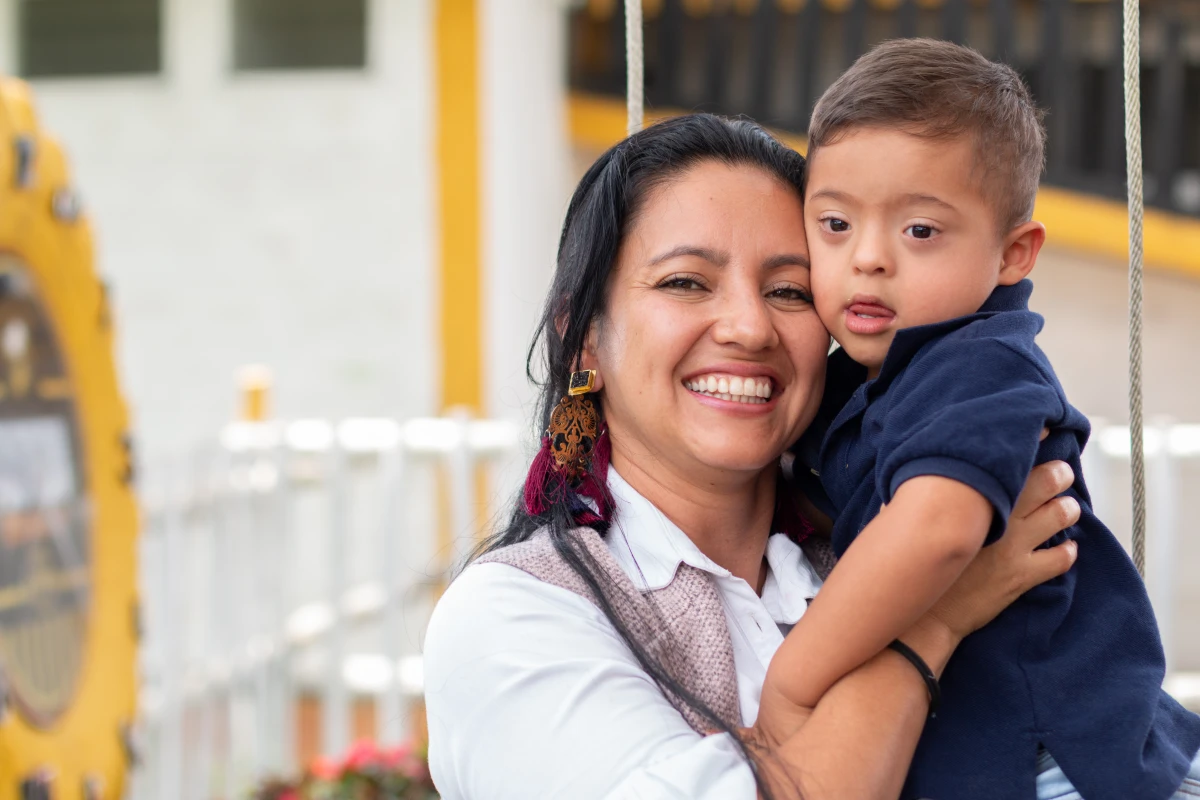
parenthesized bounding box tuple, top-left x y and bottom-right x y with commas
(769, 476, 994, 708)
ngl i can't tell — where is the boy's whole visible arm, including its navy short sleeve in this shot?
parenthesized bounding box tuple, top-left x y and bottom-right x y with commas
(770, 331, 1066, 705)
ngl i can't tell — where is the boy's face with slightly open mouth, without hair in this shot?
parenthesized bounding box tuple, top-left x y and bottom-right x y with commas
(804, 128, 1019, 378)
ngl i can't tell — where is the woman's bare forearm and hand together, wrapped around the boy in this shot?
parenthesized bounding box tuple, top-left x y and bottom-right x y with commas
(750, 462, 1079, 800)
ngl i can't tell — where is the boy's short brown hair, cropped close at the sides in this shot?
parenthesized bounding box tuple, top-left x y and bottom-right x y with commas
(809, 38, 1045, 231)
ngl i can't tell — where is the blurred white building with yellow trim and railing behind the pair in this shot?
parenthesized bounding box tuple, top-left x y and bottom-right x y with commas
(0, 0, 1200, 800)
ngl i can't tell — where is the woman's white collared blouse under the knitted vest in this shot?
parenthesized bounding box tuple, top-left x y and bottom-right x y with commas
(425, 470, 821, 800)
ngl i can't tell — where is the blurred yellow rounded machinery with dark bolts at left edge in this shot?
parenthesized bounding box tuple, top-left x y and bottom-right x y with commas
(0, 78, 136, 800)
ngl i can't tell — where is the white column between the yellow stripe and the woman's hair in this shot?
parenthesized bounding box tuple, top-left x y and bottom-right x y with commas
(480, 0, 572, 438)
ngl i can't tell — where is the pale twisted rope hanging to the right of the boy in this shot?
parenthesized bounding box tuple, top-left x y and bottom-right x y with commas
(1122, 0, 1146, 578)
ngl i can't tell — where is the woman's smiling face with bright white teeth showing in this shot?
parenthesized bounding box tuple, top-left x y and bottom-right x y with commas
(583, 161, 829, 480)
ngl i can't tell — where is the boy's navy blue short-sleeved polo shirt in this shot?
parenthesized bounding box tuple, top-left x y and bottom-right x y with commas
(799, 281, 1200, 800)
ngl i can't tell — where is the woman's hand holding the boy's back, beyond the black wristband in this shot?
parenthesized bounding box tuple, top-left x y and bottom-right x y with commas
(926, 461, 1080, 639)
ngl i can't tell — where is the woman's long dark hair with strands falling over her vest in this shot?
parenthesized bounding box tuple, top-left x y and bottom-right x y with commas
(476, 114, 804, 798)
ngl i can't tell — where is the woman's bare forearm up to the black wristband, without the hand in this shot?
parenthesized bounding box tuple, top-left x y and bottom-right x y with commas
(763, 620, 959, 800)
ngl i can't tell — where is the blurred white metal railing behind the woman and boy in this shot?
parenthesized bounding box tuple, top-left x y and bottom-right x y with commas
(131, 416, 1200, 800)
